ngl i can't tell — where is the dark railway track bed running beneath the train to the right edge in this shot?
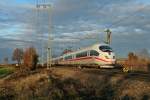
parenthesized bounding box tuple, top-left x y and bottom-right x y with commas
(49, 66, 150, 80)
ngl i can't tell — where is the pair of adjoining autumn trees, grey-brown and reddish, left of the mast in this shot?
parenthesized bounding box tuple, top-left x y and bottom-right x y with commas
(12, 47, 39, 70)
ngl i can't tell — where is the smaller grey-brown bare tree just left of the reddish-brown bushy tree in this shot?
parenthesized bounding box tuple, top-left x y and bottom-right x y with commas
(12, 48, 23, 65)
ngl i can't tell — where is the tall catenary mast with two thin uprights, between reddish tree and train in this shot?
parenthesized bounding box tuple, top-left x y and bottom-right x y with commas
(36, 0, 52, 69)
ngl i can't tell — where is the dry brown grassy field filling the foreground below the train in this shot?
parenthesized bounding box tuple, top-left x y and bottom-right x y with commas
(0, 67, 150, 100)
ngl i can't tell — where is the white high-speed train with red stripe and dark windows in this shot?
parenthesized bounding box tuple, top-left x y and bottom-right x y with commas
(52, 44, 116, 68)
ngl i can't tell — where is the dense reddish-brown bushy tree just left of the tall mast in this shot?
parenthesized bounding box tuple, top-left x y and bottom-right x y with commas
(23, 47, 38, 70)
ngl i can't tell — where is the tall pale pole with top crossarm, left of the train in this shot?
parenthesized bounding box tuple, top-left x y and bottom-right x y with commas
(36, 0, 52, 69)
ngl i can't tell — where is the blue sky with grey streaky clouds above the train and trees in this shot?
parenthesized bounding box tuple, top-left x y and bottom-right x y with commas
(0, 0, 150, 62)
